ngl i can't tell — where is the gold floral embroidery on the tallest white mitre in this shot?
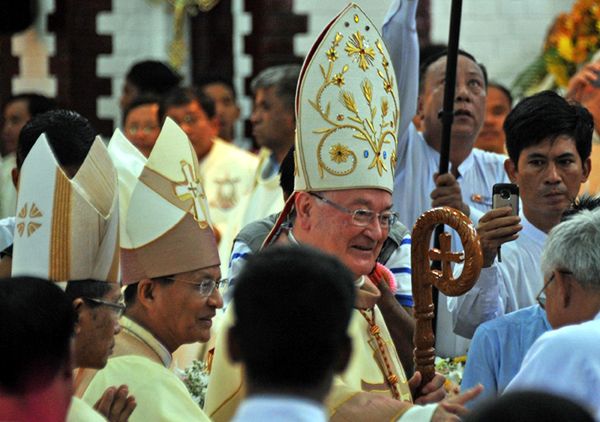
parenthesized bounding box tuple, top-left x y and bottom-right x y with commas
(308, 25, 399, 178)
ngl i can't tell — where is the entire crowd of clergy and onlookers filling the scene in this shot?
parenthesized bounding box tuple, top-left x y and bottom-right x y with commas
(0, 0, 600, 422)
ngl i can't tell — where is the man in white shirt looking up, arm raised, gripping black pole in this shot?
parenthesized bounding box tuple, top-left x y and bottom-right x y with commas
(383, 0, 508, 356)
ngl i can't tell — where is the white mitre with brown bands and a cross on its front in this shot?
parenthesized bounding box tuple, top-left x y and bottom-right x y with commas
(109, 118, 219, 284)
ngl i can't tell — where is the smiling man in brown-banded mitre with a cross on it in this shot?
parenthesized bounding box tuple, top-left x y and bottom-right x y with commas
(78, 119, 223, 422)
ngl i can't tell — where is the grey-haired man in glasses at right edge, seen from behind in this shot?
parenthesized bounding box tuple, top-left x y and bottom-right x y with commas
(507, 210, 600, 419)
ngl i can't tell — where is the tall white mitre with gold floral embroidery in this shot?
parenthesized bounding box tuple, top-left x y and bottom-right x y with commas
(295, 4, 399, 192)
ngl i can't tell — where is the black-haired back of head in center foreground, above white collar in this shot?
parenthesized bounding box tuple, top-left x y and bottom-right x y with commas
(231, 245, 354, 390)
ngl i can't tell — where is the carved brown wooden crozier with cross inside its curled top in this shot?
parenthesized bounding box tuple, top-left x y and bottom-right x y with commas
(412, 207, 483, 385)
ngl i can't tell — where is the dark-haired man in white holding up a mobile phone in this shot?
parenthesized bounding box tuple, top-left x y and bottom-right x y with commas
(449, 91, 594, 338)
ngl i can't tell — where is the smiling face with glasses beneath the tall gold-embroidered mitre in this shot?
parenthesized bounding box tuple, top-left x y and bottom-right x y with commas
(294, 189, 392, 277)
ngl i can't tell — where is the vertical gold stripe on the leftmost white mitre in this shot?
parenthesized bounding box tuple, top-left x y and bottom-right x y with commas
(48, 169, 71, 281)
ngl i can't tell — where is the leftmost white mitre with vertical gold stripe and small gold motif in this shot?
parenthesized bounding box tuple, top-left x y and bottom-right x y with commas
(12, 134, 119, 283)
